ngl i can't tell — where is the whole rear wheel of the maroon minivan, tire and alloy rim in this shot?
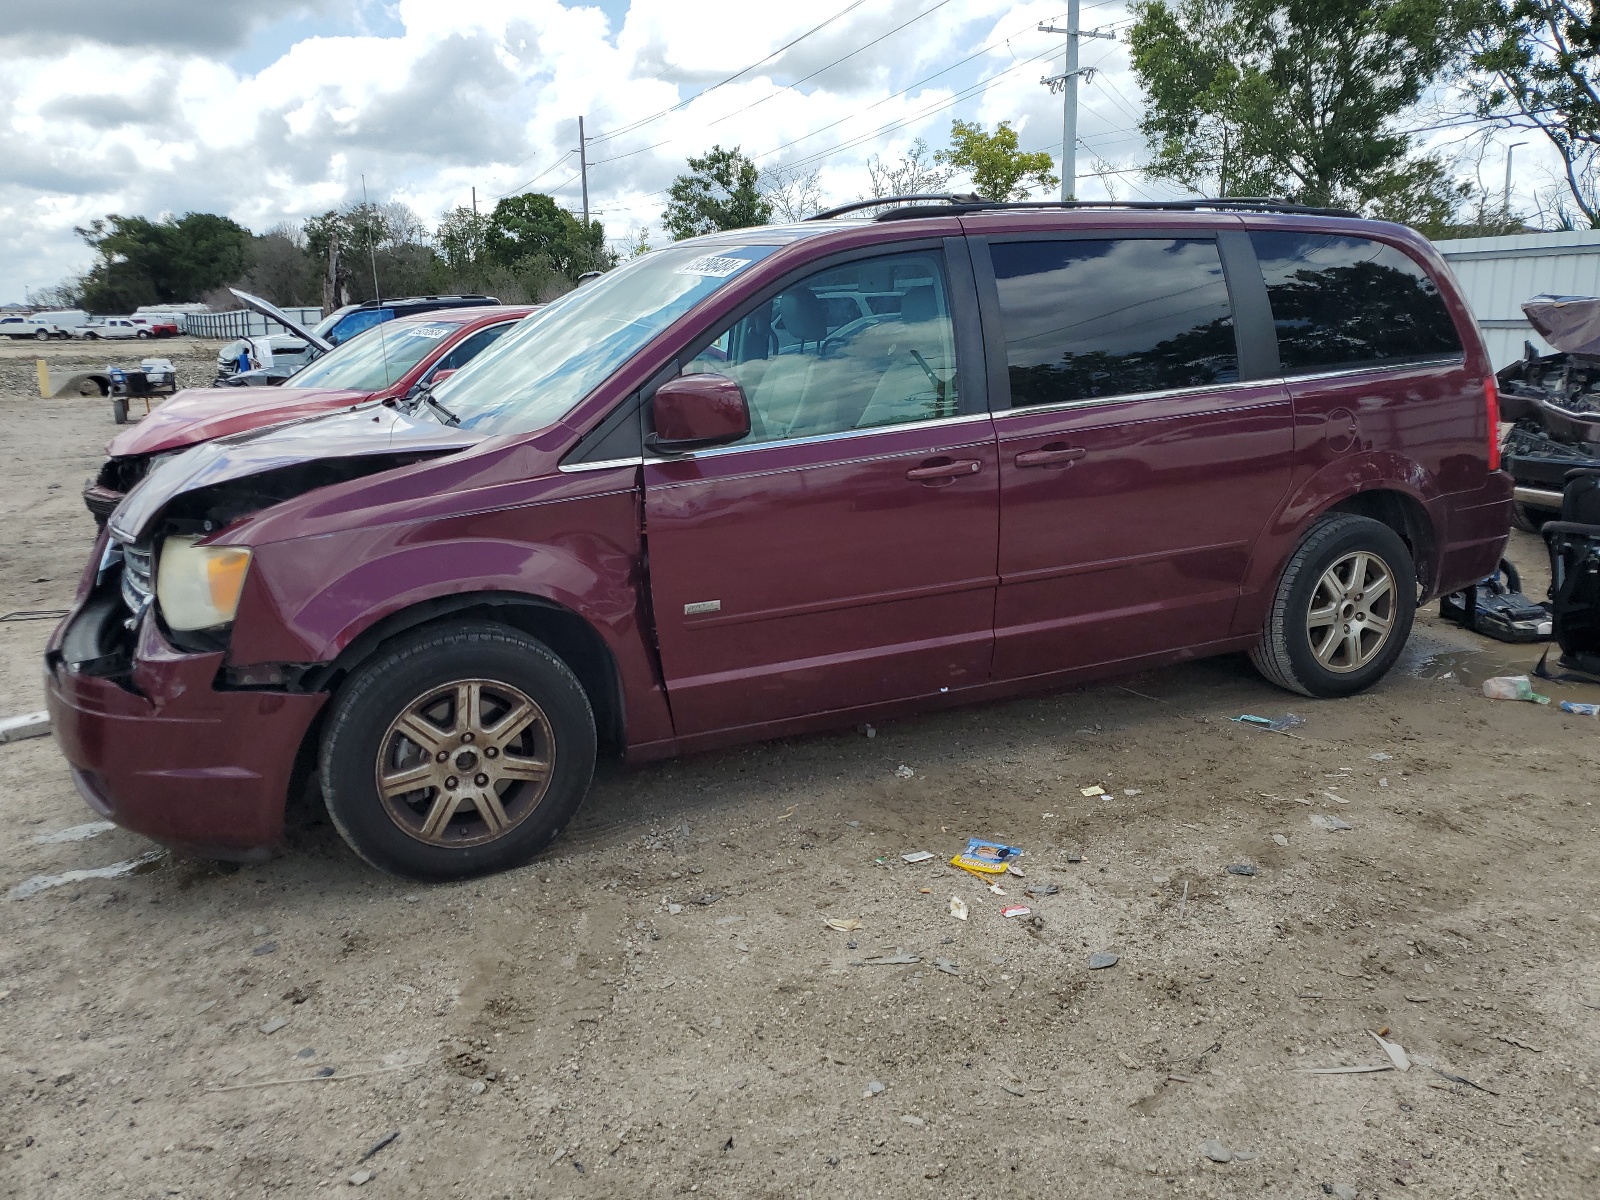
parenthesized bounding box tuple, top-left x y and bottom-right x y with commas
(1250, 512, 1416, 696)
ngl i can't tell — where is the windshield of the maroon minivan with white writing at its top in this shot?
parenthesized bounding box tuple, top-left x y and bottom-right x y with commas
(432, 246, 778, 434)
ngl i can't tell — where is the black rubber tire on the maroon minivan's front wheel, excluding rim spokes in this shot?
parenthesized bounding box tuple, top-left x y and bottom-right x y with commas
(320, 622, 595, 880)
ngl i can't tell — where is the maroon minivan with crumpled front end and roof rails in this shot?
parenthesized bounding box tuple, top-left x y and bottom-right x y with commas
(46, 197, 1510, 878)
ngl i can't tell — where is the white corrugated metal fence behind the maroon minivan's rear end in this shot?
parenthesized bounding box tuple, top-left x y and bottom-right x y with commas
(1434, 229, 1600, 370)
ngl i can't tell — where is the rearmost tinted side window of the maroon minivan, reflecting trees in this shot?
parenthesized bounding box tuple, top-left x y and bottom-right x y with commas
(1250, 232, 1461, 374)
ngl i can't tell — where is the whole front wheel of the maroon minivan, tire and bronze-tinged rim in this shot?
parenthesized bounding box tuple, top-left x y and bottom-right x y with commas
(322, 622, 595, 880)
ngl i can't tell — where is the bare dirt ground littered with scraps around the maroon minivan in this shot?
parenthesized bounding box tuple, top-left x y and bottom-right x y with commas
(0, 344, 1600, 1200)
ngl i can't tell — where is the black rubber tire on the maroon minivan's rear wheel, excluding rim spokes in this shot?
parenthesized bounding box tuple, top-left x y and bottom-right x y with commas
(1250, 514, 1416, 696)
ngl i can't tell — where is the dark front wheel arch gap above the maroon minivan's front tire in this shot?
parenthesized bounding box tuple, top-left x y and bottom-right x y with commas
(301, 592, 627, 752)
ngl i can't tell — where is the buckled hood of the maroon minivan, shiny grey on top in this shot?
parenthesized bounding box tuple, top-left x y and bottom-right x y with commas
(110, 403, 483, 544)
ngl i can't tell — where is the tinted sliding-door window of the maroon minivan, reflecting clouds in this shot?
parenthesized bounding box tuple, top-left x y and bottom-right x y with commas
(989, 238, 1238, 406)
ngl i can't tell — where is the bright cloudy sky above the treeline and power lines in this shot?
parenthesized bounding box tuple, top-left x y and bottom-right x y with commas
(0, 0, 1538, 302)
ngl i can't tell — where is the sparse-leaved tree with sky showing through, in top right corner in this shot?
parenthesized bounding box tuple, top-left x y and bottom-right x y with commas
(1470, 0, 1600, 229)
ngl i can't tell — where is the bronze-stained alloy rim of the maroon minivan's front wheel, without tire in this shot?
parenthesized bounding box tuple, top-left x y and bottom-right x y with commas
(376, 678, 555, 850)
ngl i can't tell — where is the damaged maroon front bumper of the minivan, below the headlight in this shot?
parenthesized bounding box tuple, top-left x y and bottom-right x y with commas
(45, 560, 328, 859)
